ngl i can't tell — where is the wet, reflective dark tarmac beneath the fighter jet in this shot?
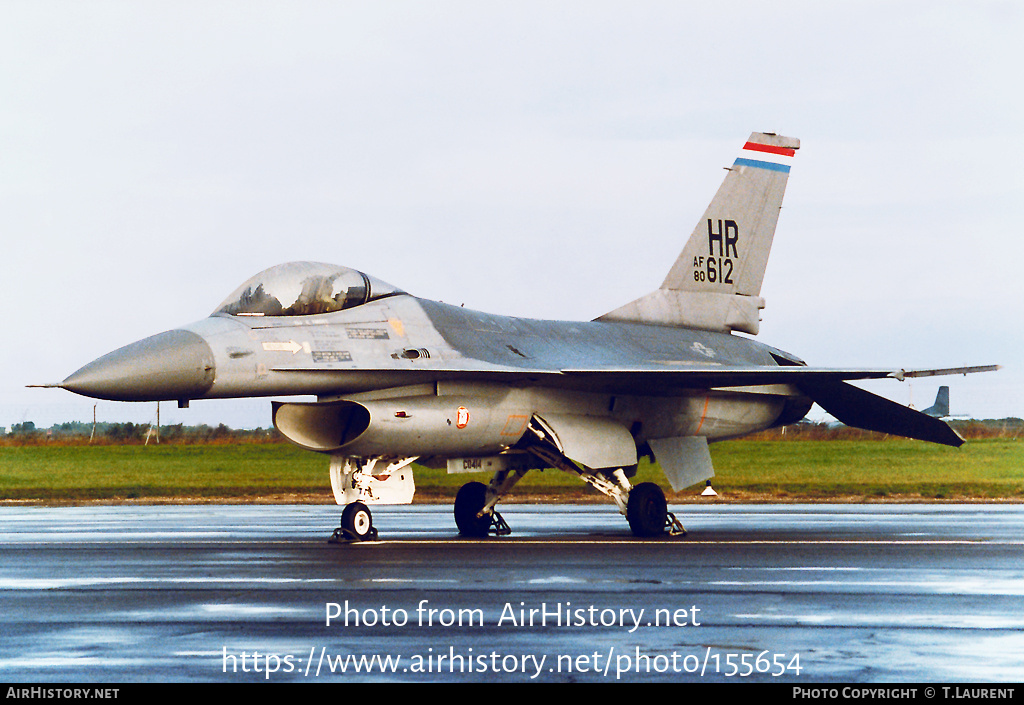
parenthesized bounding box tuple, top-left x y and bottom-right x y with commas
(0, 504, 1024, 683)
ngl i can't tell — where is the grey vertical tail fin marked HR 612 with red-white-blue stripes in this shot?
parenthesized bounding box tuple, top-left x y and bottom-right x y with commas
(598, 132, 800, 335)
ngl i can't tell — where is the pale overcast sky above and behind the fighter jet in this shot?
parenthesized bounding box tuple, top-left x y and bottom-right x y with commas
(0, 0, 1024, 426)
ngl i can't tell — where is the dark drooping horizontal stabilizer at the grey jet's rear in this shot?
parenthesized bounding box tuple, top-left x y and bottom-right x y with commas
(798, 378, 964, 448)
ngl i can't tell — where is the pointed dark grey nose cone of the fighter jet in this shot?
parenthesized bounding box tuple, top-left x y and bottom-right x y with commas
(60, 330, 215, 402)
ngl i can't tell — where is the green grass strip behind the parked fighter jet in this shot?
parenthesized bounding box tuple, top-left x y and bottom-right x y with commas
(0, 439, 1024, 502)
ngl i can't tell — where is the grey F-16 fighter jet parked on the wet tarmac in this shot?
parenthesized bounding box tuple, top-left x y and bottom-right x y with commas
(56, 132, 995, 540)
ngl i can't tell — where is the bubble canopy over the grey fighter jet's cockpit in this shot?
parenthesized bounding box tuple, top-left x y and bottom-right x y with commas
(214, 262, 406, 316)
